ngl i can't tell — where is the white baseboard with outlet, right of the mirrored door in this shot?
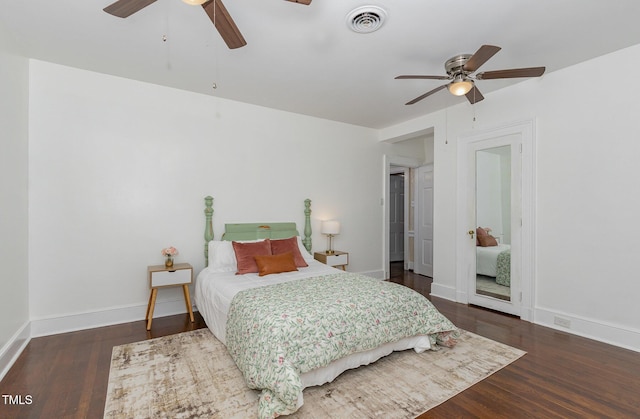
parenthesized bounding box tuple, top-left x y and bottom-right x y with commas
(534, 307, 640, 352)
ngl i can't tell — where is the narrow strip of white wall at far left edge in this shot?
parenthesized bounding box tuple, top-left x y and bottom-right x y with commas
(0, 50, 29, 379)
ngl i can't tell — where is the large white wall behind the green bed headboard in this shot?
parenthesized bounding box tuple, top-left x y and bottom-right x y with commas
(29, 61, 408, 335)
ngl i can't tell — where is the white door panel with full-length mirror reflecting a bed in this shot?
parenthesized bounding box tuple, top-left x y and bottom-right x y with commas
(465, 134, 522, 316)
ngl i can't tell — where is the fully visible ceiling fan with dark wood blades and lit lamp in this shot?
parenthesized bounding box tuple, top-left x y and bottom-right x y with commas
(396, 45, 545, 105)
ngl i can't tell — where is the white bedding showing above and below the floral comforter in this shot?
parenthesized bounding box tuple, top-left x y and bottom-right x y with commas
(195, 258, 431, 394)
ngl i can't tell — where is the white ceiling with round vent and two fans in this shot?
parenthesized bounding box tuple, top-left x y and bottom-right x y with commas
(0, 0, 640, 128)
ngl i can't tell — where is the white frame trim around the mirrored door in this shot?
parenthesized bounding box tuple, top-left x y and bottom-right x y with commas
(456, 119, 536, 322)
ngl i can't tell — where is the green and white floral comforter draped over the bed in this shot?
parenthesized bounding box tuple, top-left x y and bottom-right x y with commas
(226, 273, 459, 418)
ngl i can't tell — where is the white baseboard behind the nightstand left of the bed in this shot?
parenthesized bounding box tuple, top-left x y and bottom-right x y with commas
(31, 299, 196, 337)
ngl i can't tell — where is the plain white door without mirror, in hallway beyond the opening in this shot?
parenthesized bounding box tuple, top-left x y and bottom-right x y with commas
(413, 165, 433, 277)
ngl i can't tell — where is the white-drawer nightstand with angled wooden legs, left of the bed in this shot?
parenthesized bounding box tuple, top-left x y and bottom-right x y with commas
(145, 263, 194, 330)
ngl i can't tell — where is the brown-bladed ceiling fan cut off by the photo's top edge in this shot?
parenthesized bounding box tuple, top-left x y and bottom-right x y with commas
(103, 0, 311, 49)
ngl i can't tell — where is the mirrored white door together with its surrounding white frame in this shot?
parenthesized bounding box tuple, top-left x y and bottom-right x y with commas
(457, 122, 533, 320)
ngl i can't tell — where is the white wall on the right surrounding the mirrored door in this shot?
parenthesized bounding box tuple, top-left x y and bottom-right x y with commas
(381, 45, 640, 350)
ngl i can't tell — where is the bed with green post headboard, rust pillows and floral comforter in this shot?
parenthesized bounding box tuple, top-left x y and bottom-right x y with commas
(195, 197, 459, 418)
